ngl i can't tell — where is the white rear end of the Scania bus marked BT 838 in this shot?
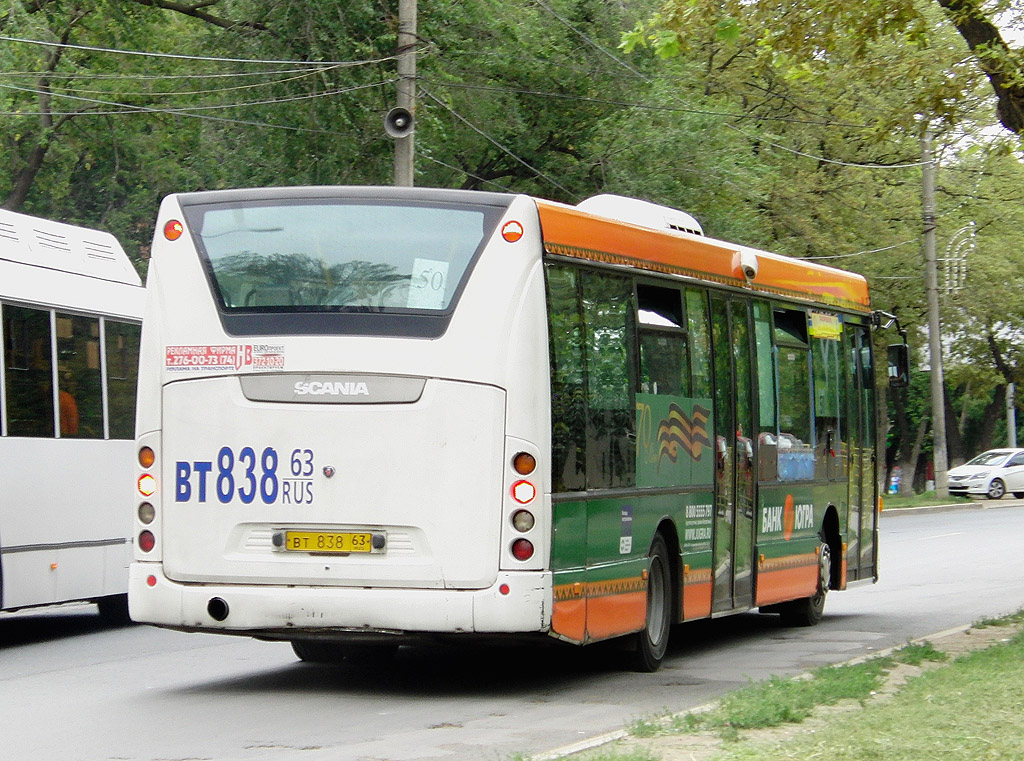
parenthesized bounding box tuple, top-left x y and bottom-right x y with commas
(130, 187, 551, 654)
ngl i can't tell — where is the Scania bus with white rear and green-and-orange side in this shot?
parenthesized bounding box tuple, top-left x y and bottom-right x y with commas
(129, 187, 892, 670)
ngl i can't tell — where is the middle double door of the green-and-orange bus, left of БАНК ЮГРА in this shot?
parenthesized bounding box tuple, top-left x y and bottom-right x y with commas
(711, 295, 755, 612)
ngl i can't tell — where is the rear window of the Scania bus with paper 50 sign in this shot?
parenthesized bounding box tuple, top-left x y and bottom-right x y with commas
(184, 199, 502, 335)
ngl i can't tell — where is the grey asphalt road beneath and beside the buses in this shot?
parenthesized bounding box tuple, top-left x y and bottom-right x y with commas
(6, 500, 1024, 761)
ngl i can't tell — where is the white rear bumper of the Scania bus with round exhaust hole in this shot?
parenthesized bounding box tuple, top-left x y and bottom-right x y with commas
(128, 562, 552, 639)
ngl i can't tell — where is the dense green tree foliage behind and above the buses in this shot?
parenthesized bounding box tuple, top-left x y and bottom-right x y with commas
(0, 0, 1024, 449)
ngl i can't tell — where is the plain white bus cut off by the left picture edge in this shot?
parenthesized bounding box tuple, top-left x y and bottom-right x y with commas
(0, 210, 145, 619)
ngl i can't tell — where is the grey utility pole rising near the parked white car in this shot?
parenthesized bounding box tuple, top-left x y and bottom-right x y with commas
(921, 128, 949, 498)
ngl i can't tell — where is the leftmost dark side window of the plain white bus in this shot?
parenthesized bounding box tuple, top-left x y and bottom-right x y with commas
(3, 305, 53, 437)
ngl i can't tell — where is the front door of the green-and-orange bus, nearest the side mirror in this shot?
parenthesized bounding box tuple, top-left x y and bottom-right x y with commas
(845, 326, 878, 582)
